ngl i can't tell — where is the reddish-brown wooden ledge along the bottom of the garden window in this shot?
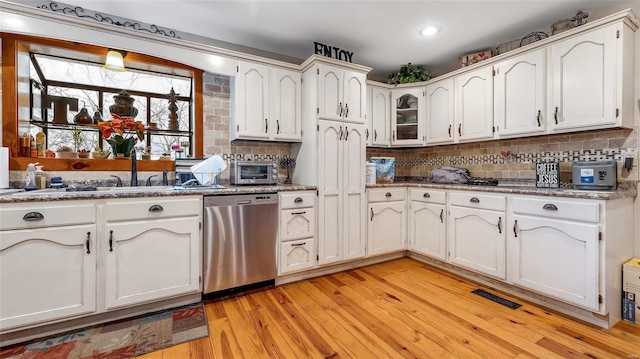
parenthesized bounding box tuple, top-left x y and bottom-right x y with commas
(9, 157, 175, 171)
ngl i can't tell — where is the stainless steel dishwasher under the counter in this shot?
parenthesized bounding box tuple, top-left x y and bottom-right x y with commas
(203, 193, 278, 294)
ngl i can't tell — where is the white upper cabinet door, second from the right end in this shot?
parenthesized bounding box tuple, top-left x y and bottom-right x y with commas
(494, 49, 547, 137)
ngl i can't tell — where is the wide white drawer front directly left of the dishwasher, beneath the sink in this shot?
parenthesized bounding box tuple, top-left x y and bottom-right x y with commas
(103, 197, 202, 222)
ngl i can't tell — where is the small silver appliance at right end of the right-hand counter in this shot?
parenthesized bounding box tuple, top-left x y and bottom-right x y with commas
(572, 160, 617, 191)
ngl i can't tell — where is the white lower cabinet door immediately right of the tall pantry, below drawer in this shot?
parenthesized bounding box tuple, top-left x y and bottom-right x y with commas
(367, 202, 407, 256)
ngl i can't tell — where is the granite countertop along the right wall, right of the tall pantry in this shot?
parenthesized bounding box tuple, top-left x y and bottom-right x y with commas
(367, 182, 638, 200)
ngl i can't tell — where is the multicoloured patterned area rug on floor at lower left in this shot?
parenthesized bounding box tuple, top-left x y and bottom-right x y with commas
(0, 303, 209, 359)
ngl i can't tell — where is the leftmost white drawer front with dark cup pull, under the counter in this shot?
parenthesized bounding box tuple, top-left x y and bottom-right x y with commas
(0, 201, 96, 230)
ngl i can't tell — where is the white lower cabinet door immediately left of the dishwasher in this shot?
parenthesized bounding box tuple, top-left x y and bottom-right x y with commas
(101, 217, 202, 309)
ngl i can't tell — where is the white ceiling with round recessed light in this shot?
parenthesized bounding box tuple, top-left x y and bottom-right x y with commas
(17, 0, 624, 78)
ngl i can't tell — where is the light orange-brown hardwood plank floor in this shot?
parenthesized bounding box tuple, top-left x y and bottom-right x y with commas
(141, 258, 640, 359)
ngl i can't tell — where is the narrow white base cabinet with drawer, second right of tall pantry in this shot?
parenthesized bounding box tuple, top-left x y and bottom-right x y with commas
(407, 188, 447, 261)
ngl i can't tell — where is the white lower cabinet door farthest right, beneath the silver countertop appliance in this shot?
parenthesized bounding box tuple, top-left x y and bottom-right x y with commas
(508, 215, 599, 311)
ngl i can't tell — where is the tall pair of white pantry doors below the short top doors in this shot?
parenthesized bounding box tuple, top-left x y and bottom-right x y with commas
(318, 120, 366, 265)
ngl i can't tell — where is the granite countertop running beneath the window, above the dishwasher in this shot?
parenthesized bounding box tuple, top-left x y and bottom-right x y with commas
(0, 184, 317, 203)
